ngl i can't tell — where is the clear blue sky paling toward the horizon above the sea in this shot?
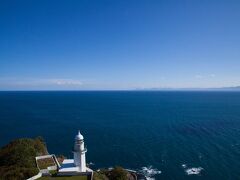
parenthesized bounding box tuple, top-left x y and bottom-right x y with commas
(0, 0, 240, 90)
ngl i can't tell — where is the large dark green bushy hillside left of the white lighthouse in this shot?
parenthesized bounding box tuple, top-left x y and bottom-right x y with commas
(0, 137, 47, 180)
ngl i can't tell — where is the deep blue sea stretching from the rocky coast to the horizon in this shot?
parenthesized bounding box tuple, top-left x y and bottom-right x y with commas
(0, 91, 240, 179)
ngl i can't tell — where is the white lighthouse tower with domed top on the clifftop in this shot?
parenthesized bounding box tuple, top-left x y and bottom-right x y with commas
(73, 131, 87, 172)
